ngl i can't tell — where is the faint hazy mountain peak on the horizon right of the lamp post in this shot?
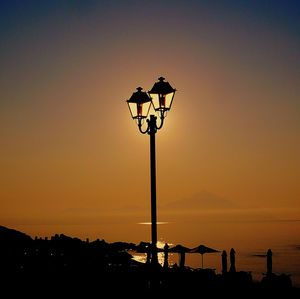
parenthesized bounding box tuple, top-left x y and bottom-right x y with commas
(163, 191, 236, 211)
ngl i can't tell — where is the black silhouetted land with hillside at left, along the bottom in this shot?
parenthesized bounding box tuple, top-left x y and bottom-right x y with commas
(0, 226, 300, 298)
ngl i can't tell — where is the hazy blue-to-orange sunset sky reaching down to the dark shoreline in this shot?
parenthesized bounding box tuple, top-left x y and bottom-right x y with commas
(0, 0, 300, 245)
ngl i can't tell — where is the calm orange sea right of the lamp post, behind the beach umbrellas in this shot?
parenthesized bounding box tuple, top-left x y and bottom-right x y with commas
(130, 209, 300, 287)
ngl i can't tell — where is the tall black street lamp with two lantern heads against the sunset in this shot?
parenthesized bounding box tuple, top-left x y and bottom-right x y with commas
(127, 77, 176, 265)
